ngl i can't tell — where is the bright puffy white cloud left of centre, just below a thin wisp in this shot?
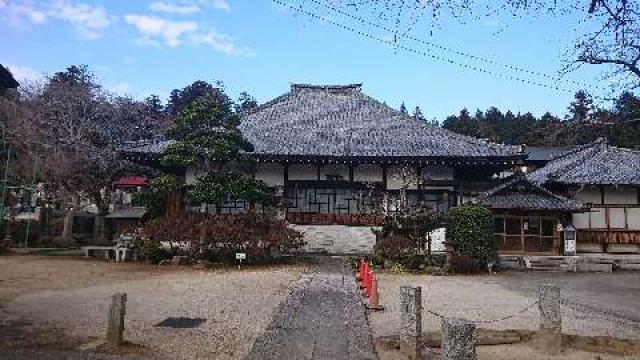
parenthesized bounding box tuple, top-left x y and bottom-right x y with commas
(124, 14, 198, 47)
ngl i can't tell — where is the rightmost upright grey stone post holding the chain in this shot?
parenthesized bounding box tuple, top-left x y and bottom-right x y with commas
(537, 284, 562, 354)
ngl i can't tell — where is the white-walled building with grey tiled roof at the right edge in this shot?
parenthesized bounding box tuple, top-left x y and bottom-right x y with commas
(529, 138, 640, 252)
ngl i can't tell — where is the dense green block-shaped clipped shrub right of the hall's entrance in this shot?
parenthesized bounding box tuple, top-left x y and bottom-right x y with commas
(447, 206, 496, 264)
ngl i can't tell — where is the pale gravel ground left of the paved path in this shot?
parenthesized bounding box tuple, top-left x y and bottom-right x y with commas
(0, 258, 302, 359)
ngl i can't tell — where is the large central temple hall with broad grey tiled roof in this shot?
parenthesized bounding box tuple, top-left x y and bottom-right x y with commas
(122, 84, 525, 225)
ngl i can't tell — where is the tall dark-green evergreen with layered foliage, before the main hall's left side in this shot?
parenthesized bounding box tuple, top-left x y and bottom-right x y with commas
(162, 95, 273, 211)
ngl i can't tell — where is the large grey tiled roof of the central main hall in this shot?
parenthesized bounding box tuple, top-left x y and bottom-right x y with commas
(240, 84, 520, 158)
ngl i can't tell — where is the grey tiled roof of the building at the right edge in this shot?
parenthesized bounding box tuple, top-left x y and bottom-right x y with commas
(529, 138, 640, 185)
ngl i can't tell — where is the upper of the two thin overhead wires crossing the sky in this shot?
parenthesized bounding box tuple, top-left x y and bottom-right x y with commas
(288, 0, 602, 94)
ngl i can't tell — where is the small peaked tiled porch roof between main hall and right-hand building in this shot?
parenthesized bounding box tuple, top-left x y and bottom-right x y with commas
(475, 173, 584, 212)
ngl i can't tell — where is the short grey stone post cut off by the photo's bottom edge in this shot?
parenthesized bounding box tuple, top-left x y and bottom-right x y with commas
(441, 318, 476, 360)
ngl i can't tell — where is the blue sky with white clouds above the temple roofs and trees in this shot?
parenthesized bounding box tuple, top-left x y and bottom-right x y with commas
(0, 0, 606, 120)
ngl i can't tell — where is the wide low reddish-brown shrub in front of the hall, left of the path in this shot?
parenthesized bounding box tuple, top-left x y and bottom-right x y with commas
(142, 212, 304, 263)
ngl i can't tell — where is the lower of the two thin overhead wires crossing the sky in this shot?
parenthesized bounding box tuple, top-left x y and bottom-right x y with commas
(271, 0, 598, 98)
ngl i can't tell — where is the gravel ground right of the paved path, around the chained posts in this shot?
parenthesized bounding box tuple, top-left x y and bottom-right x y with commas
(369, 273, 640, 359)
